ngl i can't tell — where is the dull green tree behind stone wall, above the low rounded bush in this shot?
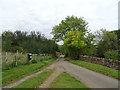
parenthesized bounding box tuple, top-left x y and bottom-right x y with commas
(97, 29, 118, 57)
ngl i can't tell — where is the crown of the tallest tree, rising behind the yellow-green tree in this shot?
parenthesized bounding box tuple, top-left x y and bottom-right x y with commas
(51, 16, 88, 42)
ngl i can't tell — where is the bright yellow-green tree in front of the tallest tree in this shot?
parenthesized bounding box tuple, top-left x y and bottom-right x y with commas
(64, 30, 86, 59)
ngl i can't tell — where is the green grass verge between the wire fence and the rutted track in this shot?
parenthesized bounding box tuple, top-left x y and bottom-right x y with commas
(2, 58, 55, 86)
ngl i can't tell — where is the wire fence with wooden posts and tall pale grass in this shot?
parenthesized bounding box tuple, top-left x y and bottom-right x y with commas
(0, 52, 51, 71)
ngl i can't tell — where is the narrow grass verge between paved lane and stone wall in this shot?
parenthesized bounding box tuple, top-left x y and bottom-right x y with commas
(69, 60, 120, 79)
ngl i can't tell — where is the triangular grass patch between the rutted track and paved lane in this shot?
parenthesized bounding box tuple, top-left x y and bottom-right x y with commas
(50, 72, 87, 88)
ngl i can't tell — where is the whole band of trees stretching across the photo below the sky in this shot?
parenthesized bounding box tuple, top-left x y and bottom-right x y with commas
(2, 16, 120, 60)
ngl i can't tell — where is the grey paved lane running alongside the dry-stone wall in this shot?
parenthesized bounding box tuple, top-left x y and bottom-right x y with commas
(40, 57, 118, 88)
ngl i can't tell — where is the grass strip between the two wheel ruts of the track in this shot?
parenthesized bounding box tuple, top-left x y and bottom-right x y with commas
(13, 70, 53, 88)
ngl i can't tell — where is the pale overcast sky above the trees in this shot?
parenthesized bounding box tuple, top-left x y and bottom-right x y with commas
(0, 0, 119, 38)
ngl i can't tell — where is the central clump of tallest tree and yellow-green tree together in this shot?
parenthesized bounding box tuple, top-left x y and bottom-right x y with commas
(52, 16, 94, 59)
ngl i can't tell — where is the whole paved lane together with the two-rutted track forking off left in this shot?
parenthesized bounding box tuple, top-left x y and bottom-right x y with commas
(3, 56, 118, 88)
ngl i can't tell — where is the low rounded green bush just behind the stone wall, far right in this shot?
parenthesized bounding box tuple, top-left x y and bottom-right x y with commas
(104, 50, 119, 60)
